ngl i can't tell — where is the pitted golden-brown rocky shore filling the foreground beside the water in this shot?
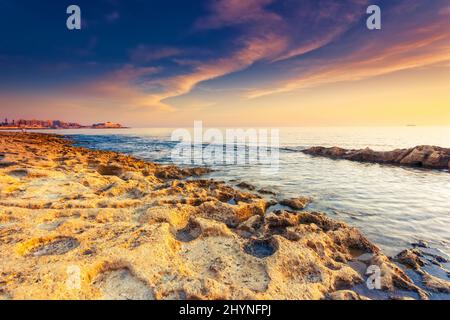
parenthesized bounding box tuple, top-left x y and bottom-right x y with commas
(0, 132, 450, 299)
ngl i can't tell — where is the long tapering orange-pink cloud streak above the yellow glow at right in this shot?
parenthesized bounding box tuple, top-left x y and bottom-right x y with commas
(246, 22, 450, 99)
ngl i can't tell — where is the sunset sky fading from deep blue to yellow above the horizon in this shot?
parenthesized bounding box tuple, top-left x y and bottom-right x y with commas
(0, 0, 450, 127)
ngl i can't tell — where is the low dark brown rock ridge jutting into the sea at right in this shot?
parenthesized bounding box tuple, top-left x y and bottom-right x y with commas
(302, 146, 450, 169)
